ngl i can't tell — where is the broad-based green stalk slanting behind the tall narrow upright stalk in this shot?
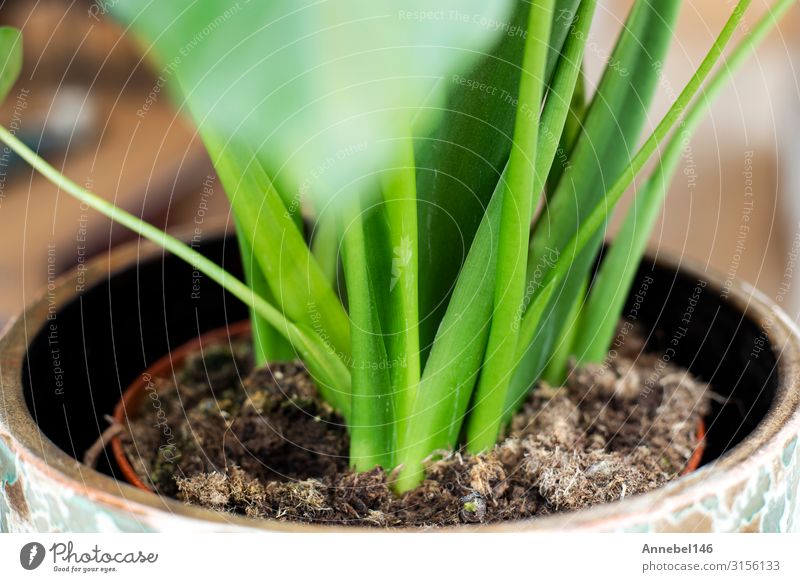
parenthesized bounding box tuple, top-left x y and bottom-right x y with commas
(395, 0, 596, 492)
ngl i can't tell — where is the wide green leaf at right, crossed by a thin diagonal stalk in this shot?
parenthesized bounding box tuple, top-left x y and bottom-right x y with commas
(507, 0, 680, 409)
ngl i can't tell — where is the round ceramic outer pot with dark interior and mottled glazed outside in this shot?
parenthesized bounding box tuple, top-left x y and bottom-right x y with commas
(0, 230, 800, 532)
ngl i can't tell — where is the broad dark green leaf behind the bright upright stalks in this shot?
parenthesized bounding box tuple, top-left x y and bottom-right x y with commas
(416, 0, 579, 364)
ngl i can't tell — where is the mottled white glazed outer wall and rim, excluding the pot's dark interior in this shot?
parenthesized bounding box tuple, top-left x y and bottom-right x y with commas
(0, 234, 800, 532)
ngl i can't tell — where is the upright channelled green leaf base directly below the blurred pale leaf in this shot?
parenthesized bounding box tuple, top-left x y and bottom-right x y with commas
(343, 139, 420, 470)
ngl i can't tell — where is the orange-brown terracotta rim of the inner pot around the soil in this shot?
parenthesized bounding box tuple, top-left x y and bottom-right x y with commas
(111, 320, 706, 492)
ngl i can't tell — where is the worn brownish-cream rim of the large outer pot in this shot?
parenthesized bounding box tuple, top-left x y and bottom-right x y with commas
(0, 229, 800, 533)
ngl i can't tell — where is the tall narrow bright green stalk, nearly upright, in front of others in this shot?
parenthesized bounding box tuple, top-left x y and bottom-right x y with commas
(467, 0, 553, 453)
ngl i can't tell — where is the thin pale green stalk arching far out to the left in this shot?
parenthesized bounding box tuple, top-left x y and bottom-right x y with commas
(0, 126, 350, 417)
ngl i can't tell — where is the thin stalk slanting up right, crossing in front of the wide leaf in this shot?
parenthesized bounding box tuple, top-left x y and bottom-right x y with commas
(520, 0, 751, 364)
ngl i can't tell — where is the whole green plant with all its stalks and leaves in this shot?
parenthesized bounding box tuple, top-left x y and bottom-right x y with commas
(0, 0, 792, 492)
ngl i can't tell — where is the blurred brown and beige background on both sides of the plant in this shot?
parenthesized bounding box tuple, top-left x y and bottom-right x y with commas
(0, 0, 800, 325)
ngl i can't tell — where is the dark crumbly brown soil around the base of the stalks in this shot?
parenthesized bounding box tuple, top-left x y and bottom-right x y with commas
(123, 328, 710, 527)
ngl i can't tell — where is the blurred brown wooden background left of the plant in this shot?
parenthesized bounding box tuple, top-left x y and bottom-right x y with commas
(0, 2, 222, 323)
